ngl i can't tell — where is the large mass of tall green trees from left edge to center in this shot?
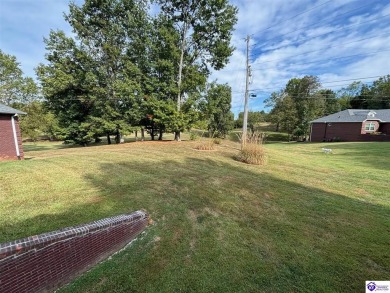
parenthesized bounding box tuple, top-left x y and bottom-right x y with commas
(0, 0, 237, 145)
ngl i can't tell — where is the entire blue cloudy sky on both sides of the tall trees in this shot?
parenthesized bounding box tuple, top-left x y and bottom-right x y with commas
(0, 0, 390, 115)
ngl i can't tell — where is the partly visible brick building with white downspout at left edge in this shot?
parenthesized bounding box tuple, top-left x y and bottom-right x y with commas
(0, 103, 26, 160)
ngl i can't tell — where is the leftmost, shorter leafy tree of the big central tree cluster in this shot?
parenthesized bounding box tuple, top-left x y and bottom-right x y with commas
(37, 31, 97, 145)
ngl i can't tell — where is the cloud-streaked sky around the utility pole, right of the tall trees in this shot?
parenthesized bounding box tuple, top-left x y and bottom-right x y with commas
(212, 0, 390, 114)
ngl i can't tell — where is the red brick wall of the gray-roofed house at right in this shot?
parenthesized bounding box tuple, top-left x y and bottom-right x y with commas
(310, 122, 390, 142)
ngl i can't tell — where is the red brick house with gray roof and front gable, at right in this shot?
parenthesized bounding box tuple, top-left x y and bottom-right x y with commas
(310, 109, 390, 142)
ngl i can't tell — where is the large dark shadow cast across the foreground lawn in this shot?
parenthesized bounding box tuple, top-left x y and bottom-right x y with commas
(2, 158, 390, 292)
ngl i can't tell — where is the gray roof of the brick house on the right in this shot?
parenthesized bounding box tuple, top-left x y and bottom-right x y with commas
(311, 109, 390, 123)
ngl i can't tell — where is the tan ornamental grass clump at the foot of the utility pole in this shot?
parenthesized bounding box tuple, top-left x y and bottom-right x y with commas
(237, 132, 267, 165)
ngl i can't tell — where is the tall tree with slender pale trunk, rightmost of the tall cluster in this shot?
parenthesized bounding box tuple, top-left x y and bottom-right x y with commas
(156, 0, 237, 140)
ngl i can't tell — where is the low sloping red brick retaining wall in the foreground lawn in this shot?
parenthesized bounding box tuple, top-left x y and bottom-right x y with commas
(0, 211, 148, 293)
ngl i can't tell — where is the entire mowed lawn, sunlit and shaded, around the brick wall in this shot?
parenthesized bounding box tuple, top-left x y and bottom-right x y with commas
(0, 141, 390, 292)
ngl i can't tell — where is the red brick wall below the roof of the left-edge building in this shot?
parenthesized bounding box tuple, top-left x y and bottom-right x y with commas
(0, 114, 24, 160)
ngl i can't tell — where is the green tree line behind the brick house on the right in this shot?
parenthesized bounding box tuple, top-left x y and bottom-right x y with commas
(264, 75, 390, 139)
